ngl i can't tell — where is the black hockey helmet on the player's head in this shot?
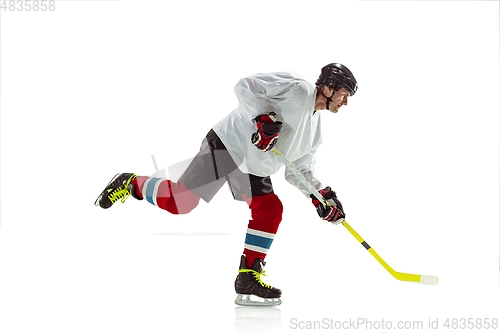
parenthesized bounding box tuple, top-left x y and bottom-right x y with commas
(316, 63, 358, 98)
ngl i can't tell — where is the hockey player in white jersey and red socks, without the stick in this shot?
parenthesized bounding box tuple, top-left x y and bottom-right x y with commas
(95, 63, 358, 305)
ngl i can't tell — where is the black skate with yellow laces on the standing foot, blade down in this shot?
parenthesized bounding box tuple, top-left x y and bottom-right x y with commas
(234, 255, 281, 306)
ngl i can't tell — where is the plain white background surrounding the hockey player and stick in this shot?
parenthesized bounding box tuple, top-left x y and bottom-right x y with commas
(0, 0, 500, 333)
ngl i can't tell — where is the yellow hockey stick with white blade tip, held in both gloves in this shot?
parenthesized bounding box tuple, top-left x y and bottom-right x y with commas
(271, 148, 439, 285)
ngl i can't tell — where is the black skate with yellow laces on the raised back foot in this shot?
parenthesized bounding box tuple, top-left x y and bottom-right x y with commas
(94, 173, 142, 209)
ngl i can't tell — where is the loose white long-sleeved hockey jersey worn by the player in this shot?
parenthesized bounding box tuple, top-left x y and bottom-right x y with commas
(213, 72, 324, 197)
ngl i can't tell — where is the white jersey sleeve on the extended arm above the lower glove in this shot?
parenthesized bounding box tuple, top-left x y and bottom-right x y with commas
(285, 150, 325, 198)
